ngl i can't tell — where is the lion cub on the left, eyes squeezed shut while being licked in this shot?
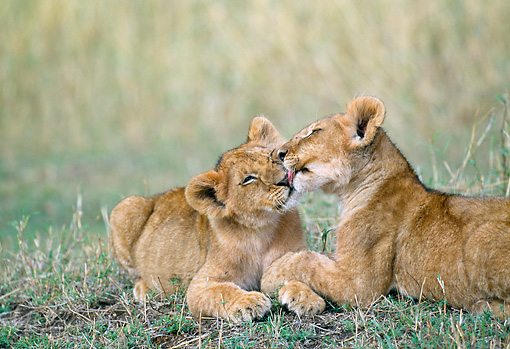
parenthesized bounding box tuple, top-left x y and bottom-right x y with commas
(110, 117, 324, 321)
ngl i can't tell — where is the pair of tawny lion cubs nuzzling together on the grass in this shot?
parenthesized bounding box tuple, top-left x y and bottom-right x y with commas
(110, 97, 510, 321)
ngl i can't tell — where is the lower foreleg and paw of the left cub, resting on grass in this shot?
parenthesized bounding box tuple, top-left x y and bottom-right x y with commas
(186, 273, 271, 322)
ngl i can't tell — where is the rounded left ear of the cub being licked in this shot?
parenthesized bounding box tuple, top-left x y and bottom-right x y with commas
(185, 170, 226, 217)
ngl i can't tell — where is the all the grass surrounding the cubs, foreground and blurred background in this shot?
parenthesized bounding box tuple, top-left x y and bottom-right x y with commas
(0, 0, 510, 348)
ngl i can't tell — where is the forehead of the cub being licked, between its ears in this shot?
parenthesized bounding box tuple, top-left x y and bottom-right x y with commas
(216, 145, 272, 171)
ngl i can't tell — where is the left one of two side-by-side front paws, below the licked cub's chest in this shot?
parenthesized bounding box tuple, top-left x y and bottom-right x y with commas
(225, 291, 271, 323)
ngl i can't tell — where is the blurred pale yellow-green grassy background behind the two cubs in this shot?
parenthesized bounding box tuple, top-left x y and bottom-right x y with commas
(0, 0, 510, 248)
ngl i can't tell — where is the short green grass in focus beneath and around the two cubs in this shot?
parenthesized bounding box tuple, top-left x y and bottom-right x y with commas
(0, 99, 510, 348)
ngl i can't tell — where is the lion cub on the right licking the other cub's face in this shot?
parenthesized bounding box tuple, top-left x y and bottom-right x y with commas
(262, 97, 510, 318)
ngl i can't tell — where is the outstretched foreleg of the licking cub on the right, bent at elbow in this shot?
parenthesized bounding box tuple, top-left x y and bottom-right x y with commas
(261, 251, 391, 308)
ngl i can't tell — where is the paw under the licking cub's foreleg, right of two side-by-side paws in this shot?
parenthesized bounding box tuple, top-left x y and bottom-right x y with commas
(278, 281, 326, 316)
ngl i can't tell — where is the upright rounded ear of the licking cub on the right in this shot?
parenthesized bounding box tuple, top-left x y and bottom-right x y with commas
(344, 97, 386, 147)
